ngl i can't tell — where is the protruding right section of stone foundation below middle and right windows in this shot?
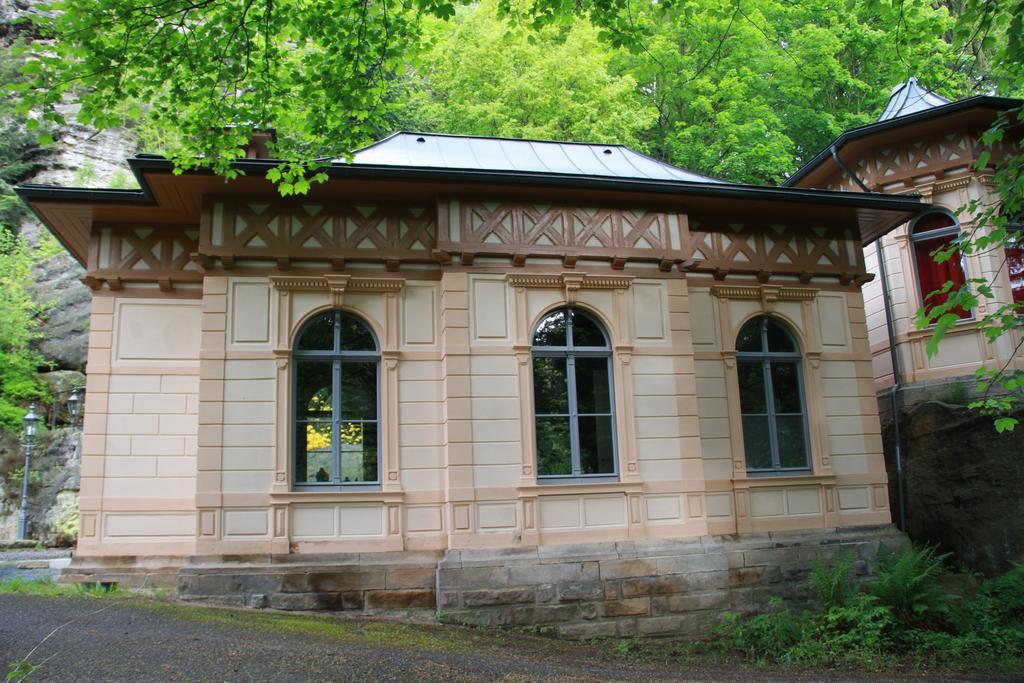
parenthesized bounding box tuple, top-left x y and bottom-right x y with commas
(437, 526, 905, 638)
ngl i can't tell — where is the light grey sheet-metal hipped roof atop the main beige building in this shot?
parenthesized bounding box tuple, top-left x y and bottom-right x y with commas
(334, 131, 722, 183)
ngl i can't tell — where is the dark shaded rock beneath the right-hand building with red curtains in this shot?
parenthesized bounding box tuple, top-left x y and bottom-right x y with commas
(883, 400, 1024, 575)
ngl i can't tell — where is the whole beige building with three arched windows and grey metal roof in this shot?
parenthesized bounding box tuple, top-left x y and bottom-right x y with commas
(20, 133, 924, 635)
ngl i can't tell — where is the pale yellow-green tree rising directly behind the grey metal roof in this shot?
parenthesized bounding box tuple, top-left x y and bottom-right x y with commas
(406, 0, 656, 146)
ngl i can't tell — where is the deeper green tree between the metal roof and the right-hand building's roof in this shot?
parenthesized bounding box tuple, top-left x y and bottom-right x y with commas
(620, 0, 968, 183)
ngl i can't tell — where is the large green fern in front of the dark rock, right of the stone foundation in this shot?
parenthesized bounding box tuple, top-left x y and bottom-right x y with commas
(868, 546, 949, 626)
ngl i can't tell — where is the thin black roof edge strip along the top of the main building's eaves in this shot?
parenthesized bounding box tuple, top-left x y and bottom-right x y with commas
(14, 157, 921, 211)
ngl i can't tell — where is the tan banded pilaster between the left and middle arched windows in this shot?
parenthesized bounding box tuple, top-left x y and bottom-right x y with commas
(441, 272, 475, 547)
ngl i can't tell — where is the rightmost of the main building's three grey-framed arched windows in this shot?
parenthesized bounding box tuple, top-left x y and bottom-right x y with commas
(736, 315, 811, 474)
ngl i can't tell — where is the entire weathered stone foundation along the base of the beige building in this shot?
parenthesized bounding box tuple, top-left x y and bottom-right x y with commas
(70, 525, 906, 639)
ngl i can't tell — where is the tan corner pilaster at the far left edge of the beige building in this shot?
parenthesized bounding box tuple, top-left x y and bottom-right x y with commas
(78, 296, 115, 554)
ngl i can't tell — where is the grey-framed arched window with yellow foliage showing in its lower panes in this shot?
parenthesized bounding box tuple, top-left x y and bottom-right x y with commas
(293, 310, 380, 487)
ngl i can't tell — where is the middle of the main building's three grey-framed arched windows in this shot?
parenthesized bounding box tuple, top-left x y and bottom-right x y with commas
(532, 308, 616, 479)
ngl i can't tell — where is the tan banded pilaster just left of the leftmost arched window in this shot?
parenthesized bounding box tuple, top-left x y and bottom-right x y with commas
(196, 278, 227, 555)
